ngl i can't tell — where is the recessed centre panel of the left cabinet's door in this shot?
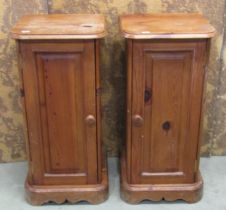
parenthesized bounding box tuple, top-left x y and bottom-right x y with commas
(37, 53, 86, 175)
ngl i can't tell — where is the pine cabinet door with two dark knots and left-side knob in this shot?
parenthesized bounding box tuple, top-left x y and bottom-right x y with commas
(131, 40, 206, 184)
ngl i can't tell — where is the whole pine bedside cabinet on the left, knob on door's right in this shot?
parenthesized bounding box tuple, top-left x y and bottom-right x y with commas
(11, 14, 108, 205)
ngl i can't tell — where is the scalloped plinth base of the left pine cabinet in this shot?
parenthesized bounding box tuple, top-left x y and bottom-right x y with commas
(25, 169, 108, 205)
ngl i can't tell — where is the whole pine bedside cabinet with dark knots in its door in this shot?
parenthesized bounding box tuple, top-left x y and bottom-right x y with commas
(120, 14, 215, 203)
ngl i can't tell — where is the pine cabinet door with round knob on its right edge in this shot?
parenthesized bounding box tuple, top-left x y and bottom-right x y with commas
(20, 40, 97, 184)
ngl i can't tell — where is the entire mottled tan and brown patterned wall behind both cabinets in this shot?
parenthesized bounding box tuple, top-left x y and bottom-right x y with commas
(0, 0, 226, 162)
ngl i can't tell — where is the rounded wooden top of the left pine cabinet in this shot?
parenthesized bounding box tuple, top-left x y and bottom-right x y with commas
(11, 14, 106, 40)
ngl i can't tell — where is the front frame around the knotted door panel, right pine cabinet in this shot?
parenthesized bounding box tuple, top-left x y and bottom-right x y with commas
(125, 39, 208, 184)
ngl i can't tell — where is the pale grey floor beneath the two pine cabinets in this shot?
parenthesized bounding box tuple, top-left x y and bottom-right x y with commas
(0, 157, 226, 210)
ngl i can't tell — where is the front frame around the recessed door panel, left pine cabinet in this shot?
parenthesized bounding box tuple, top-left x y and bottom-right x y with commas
(18, 40, 102, 185)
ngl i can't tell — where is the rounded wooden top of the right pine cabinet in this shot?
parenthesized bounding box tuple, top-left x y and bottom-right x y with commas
(120, 13, 215, 39)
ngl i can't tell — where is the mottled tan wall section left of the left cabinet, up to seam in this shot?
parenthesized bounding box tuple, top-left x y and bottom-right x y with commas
(0, 0, 48, 162)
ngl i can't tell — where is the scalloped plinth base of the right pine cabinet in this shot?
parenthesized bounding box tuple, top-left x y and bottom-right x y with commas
(121, 156, 203, 204)
